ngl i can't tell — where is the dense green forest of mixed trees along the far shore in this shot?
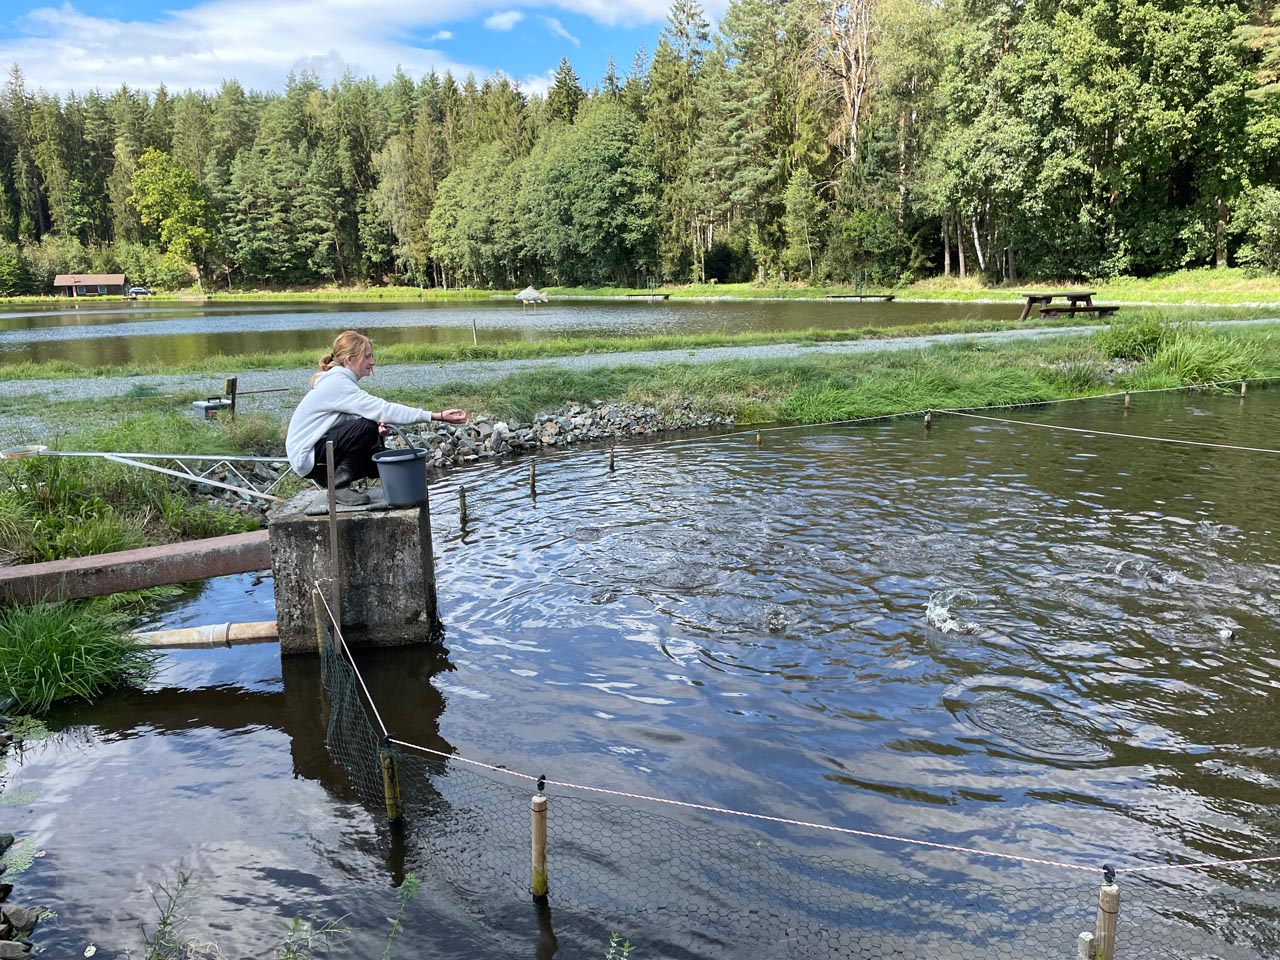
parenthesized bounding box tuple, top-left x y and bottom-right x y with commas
(0, 0, 1280, 296)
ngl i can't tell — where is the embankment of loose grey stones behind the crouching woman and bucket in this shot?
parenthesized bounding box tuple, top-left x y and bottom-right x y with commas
(201, 402, 733, 515)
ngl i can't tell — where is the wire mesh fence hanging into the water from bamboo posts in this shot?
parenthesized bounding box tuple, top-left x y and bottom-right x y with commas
(312, 619, 1280, 960)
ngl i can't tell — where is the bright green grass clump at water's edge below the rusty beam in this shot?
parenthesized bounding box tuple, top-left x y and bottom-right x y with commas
(0, 602, 156, 713)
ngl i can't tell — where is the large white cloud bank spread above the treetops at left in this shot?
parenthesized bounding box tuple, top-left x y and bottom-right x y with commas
(0, 0, 691, 93)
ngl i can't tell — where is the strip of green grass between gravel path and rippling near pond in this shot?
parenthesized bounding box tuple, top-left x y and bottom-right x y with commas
(373, 324, 1280, 425)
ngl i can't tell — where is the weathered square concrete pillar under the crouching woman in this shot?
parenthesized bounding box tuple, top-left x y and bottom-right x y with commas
(268, 490, 443, 654)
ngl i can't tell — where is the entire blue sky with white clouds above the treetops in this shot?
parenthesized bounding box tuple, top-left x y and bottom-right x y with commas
(0, 0, 727, 95)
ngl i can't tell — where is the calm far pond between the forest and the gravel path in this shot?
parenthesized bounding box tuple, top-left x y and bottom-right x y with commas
(0, 297, 1020, 366)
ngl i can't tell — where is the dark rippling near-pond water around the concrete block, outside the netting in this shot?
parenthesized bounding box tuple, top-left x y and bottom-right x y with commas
(9, 390, 1280, 957)
